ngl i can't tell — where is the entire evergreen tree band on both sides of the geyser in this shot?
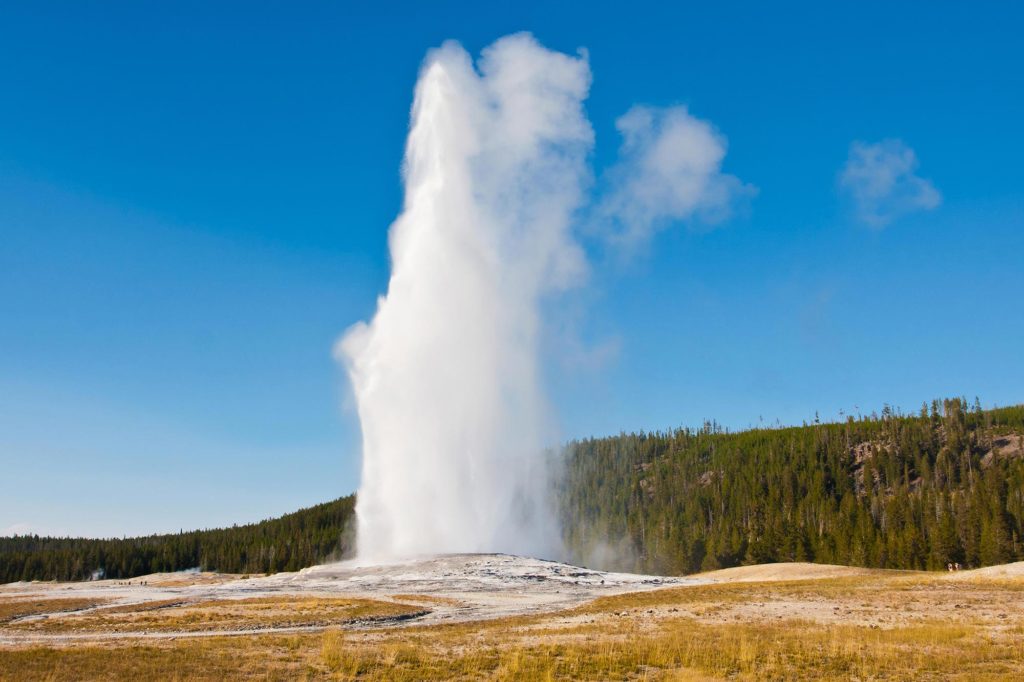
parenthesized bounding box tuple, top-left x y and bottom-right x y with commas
(0, 398, 1024, 583)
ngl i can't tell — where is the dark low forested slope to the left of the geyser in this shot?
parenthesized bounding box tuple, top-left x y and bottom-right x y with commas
(0, 495, 355, 583)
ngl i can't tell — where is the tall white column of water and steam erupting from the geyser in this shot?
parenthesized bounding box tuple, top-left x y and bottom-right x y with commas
(339, 35, 593, 561)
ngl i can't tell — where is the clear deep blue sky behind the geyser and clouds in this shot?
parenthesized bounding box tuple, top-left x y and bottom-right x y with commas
(0, 2, 1024, 536)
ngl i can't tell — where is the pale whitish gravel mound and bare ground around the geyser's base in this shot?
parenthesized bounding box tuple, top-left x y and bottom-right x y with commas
(0, 554, 709, 646)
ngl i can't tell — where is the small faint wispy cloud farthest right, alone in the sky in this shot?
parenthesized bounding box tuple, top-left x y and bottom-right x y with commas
(839, 139, 942, 228)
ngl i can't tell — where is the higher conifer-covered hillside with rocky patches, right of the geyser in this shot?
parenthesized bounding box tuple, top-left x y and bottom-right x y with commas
(560, 399, 1024, 573)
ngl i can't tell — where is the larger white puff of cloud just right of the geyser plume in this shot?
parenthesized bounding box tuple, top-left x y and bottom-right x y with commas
(601, 105, 757, 242)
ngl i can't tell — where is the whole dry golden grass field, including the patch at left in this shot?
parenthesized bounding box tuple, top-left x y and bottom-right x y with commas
(0, 564, 1024, 680)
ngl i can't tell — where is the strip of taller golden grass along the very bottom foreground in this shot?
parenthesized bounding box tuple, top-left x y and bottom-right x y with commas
(6, 622, 1024, 681)
